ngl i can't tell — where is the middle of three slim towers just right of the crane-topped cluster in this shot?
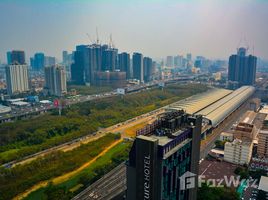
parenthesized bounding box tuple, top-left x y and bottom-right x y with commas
(132, 53, 144, 82)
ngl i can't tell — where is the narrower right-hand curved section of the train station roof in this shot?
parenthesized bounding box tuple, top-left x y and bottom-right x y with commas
(196, 86, 255, 127)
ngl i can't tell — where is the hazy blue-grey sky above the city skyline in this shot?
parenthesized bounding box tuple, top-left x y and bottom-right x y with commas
(0, 0, 268, 62)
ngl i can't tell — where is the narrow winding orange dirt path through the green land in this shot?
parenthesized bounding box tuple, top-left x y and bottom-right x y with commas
(13, 139, 123, 200)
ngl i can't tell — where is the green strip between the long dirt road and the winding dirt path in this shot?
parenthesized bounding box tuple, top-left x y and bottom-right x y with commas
(0, 134, 120, 199)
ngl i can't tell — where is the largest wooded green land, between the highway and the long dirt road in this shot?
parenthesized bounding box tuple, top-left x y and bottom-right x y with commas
(0, 84, 208, 164)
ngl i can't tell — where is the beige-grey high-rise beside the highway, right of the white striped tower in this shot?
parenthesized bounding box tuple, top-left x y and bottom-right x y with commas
(45, 65, 67, 96)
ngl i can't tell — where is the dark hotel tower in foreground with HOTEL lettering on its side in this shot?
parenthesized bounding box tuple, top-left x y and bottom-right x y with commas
(127, 111, 202, 200)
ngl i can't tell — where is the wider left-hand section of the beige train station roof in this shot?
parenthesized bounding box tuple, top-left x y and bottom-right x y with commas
(168, 88, 232, 114)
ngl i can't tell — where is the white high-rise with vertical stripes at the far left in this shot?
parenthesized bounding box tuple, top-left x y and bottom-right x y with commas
(6, 64, 29, 95)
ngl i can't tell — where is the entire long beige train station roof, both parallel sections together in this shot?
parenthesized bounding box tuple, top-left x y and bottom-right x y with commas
(167, 86, 255, 127)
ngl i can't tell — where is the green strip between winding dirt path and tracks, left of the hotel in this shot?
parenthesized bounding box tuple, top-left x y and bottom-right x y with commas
(25, 142, 131, 200)
